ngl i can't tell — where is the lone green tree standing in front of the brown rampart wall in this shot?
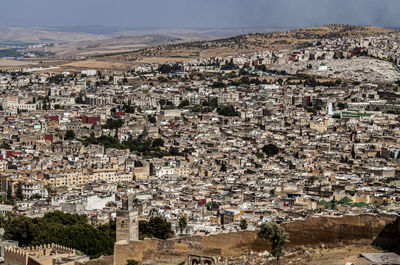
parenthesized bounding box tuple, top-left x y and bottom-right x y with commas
(258, 222, 289, 265)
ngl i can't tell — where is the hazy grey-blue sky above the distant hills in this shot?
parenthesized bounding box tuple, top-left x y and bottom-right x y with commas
(0, 0, 400, 28)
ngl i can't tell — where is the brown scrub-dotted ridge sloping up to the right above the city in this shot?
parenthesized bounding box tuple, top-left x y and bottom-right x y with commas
(95, 25, 393, 66)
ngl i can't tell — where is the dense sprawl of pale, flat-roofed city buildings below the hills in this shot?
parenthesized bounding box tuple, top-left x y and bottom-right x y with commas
(0, 4, 400, 265)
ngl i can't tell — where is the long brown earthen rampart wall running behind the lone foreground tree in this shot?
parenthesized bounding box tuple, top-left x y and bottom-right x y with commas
(114, 215, 397, 265)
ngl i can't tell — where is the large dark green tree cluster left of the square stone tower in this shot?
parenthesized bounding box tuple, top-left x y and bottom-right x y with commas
(2, 212, 115, 257)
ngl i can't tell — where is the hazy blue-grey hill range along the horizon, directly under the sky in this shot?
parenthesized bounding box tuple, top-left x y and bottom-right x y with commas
(0, 26, 284, 47)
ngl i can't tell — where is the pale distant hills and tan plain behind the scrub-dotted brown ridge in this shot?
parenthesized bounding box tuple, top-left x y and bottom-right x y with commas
(0, 26, 288, 58)
